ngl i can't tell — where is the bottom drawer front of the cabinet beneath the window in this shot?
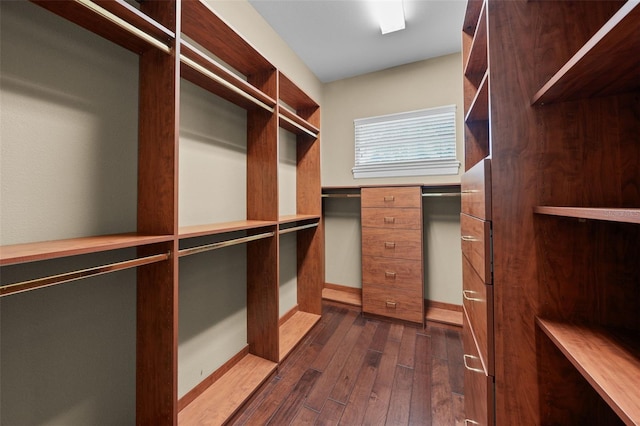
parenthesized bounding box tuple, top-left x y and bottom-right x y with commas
(362, 282, 424, 323)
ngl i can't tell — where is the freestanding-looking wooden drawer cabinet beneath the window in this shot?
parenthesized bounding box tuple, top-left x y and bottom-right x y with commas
(361, 186, 424, 323)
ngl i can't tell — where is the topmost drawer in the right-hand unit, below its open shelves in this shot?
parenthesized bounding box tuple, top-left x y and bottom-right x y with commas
(460, 158, 491, 220)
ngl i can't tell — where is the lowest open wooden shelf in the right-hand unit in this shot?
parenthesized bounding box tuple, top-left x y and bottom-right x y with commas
(537, 318, 640, 424)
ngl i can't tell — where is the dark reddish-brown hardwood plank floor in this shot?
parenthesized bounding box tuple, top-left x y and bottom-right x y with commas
(230, 305, 464, 426)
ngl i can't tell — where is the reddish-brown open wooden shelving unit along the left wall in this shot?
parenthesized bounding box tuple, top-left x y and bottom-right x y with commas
(0, 0, 324, 425)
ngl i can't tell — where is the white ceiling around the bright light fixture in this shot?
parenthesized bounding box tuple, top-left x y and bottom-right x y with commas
(249, 0, 467, 83)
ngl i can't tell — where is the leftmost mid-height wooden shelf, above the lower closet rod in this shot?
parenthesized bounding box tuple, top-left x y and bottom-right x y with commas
(0, 233, 173, 266)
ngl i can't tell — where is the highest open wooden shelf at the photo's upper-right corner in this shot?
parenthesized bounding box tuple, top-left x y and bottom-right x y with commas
(532, 1, 640, 105)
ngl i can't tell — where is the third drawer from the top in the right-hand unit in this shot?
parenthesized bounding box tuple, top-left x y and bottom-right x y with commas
(462, 256, 495, 376)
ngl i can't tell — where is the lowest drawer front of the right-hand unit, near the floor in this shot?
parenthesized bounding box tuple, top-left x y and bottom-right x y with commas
(462, 314, 494, 425)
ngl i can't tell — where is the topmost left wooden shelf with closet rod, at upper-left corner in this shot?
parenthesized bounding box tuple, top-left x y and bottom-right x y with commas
(31, 0, 175, 53)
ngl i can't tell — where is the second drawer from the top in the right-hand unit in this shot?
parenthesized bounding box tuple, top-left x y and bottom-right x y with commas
(460, 213, 491, 284)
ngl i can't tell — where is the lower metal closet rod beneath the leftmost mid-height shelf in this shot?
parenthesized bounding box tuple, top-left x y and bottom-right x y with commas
(0, 252, 171, 297)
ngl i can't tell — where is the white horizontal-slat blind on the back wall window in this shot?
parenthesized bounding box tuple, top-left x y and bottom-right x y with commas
(353, 105, 460, 178)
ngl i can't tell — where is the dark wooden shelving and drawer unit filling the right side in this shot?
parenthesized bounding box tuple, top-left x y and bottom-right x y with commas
(462, 0, 640, 425)
